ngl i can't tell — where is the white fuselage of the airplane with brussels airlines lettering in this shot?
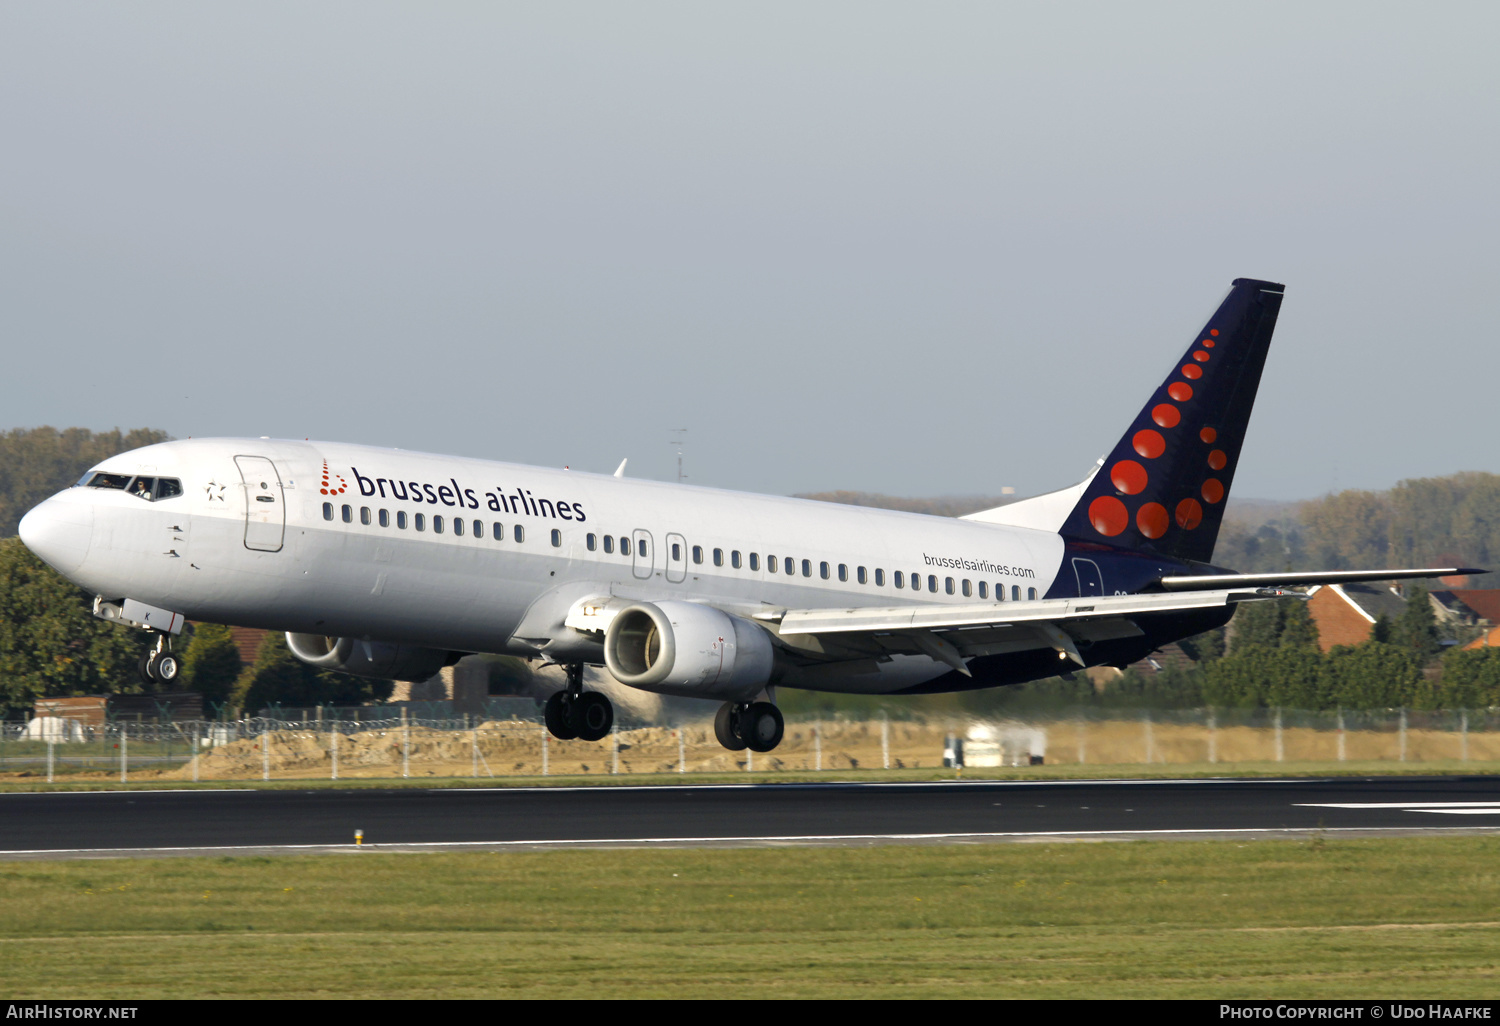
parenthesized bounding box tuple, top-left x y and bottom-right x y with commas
(14, 438, 1064, 692)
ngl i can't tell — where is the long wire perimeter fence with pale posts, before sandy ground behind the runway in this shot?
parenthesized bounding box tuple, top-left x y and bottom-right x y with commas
(0, 710, 1500, 782)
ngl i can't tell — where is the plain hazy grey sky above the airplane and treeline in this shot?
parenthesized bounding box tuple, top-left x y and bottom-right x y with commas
(0, 2, 1500, 498)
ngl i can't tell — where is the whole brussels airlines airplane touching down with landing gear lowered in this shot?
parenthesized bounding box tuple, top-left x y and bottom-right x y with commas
(20, 279, 1484, 752)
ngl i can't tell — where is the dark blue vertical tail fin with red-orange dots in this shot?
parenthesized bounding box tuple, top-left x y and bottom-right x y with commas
(1061, 278, 1286, 563)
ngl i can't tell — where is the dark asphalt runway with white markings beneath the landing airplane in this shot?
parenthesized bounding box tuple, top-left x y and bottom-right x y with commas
(0, 777, 1500, 860)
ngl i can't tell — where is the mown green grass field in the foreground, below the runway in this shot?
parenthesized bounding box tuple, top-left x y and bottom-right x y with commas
(0, 836, 1500, 999)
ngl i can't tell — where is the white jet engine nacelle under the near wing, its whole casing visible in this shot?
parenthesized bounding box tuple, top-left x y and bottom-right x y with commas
(605, 602, 776, 701)
